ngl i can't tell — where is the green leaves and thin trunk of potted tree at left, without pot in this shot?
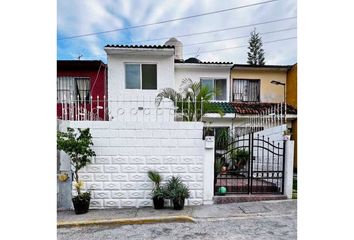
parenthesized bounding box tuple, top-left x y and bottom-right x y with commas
(57, 127, 96, 195)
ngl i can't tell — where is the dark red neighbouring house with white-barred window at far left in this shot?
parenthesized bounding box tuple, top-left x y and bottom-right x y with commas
(57, 60, 107, 119)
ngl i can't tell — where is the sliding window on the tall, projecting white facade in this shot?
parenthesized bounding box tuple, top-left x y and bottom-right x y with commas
(125, 63, 157, 89)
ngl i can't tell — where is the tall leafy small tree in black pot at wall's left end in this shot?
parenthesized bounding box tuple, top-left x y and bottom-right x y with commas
(57, 127, 96, 214)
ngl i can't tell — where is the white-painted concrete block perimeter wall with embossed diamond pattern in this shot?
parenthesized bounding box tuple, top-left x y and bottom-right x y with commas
(59, 121, 207, 208)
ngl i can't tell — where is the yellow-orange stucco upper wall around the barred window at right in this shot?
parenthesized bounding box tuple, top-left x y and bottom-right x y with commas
(231, 69, 287, 102)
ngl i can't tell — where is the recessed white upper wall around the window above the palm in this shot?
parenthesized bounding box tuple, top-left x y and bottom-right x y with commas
(175, 64, 230, 101)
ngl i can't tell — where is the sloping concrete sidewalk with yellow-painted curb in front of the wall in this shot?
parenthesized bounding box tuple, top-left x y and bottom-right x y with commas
(57, 199, 297, 227)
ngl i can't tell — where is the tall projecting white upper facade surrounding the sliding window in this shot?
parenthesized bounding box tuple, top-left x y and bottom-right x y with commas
(105, 47, 174, 121)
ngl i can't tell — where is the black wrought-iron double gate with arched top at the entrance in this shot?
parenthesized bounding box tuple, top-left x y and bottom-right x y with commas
(214, 133, 285, 195)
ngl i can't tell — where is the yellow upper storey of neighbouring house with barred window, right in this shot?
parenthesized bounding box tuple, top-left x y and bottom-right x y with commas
(231, 64, 296, 133)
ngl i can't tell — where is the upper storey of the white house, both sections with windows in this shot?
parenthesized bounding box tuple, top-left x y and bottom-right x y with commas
(104, 38, 233, 122)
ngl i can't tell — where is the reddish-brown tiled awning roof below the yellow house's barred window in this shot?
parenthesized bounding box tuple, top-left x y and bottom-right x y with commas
(231, 102, 297, 114)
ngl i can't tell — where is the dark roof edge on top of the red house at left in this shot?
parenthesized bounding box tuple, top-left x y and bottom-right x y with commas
(57, 60, 107, 71)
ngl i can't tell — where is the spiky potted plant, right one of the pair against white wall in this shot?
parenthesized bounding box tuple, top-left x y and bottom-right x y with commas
(166, 176, 190, 210)
